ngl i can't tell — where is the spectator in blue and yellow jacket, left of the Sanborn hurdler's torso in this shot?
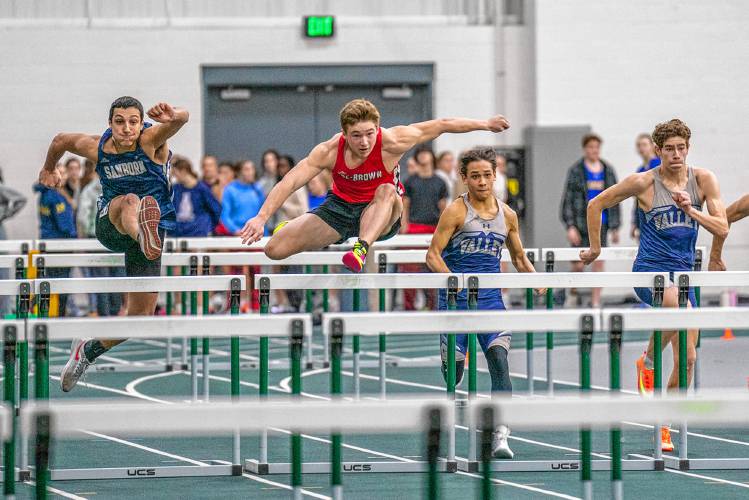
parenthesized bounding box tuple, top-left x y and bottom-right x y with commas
(34, 163, 80, 316)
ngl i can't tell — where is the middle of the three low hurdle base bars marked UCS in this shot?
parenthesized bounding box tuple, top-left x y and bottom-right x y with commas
(244, 459, 458, 476)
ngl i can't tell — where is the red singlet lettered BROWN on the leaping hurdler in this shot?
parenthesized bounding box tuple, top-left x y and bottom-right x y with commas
(332, 128, 403, 203)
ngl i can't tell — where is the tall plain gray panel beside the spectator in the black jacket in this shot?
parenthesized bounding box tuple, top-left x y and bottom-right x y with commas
(522, 125, 590, 252)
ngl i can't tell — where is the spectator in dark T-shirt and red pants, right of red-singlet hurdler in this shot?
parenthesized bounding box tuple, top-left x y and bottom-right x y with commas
(401, 144, 448, 311)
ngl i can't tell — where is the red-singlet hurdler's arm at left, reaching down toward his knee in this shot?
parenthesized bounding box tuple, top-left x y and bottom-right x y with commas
(239, 137, 337, 245)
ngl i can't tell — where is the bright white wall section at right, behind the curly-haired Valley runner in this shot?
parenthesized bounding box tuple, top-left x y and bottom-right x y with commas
(535, 0, 749, 269)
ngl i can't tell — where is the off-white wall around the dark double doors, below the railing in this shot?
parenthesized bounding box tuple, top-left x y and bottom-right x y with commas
(0, 18, 496, 238)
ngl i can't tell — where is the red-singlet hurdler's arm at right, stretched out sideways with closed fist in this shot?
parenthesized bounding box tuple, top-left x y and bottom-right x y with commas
(383, 115, 510, 155)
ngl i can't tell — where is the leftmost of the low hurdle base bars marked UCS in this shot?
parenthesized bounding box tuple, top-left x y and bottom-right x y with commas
(36, 464, 235, 481)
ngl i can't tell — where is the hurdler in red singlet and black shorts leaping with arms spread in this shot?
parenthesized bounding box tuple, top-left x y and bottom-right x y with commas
(241, 99, 509, 272)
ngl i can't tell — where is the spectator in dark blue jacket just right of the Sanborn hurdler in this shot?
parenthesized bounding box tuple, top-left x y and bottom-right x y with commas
(172, 156, 221, 237)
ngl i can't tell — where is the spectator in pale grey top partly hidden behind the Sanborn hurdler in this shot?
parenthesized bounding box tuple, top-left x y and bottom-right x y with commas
(76, 168, 125, 316)
